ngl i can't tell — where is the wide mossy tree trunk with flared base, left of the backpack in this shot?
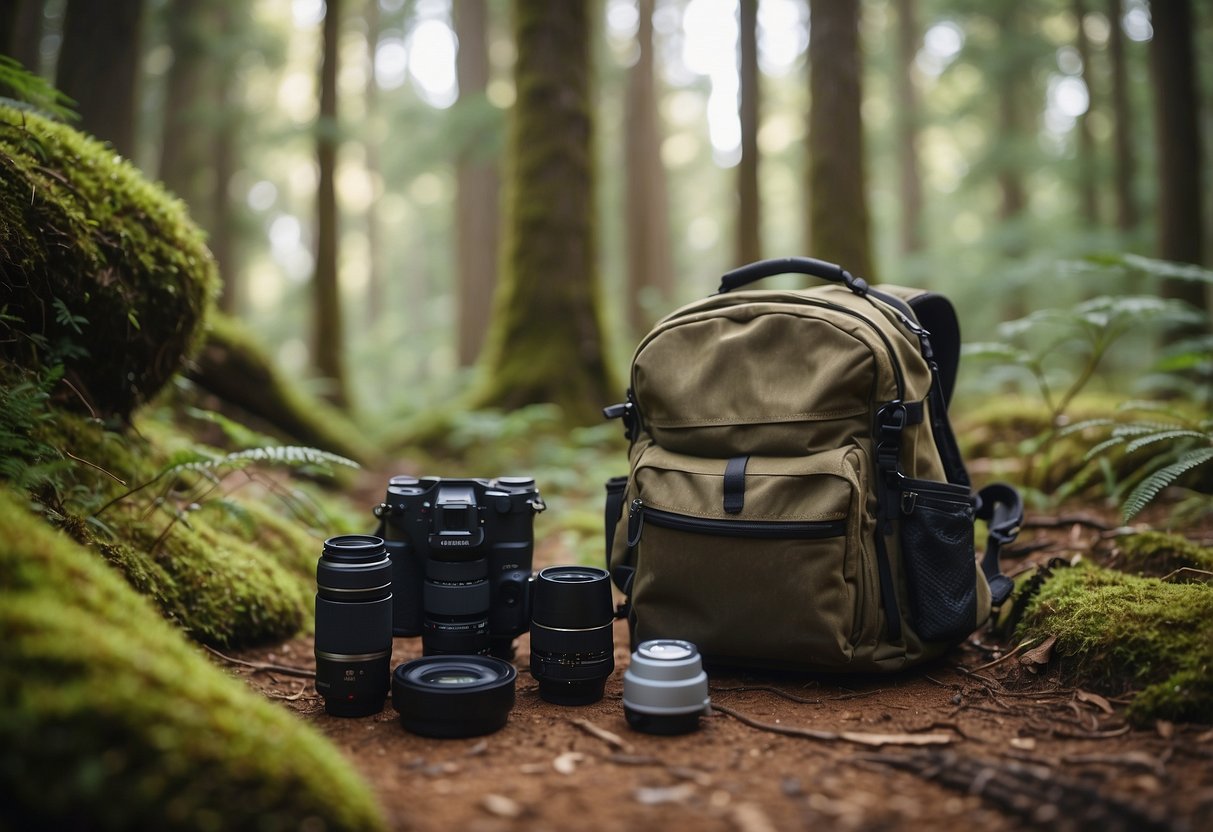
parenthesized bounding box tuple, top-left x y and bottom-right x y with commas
(472, 0, 619, 423)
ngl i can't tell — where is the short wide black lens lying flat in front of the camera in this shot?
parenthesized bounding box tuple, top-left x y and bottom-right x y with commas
(392, 656, 518, 739)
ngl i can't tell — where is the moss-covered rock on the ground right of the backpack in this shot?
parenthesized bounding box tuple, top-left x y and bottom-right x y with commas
(1018, 565, 1213, 723)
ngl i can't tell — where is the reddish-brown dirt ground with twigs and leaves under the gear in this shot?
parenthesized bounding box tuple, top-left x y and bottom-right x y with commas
(224, 514, 1213, 832)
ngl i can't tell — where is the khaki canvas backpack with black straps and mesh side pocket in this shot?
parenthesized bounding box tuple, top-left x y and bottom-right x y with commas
(605, 257, 1023, 671)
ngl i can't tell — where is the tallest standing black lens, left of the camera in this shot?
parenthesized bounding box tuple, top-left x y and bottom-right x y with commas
(315, 535, 392, 717)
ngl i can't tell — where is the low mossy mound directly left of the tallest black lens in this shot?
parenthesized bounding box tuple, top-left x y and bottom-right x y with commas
(29, 405, 331, 645)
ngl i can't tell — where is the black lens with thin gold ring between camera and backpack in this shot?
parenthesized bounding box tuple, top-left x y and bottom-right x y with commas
(531, 566, 615, 705)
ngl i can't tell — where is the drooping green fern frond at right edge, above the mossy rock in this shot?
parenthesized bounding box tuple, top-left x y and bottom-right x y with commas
(1064, 401, 1213, 523)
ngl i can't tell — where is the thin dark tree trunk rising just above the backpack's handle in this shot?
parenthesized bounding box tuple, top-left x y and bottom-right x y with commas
(734, 0, 762, 266)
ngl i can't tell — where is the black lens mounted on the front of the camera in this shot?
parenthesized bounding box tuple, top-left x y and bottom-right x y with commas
(421, 552, 490, 656)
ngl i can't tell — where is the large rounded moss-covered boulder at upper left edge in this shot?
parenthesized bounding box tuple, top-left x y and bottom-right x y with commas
(0, 104, 218, 416)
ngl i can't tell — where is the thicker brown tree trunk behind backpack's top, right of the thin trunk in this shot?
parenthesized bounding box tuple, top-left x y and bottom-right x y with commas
(808, 0, 875, 279)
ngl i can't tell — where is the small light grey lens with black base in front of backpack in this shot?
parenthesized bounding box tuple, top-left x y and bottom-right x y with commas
(623, 638, 711, 735)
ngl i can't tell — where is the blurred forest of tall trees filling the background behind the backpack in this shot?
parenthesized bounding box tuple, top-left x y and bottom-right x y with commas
(0, 0, 1213, 429)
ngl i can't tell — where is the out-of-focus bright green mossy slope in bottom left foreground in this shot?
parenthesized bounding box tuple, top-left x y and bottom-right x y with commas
(0, 489, 383, 830)
